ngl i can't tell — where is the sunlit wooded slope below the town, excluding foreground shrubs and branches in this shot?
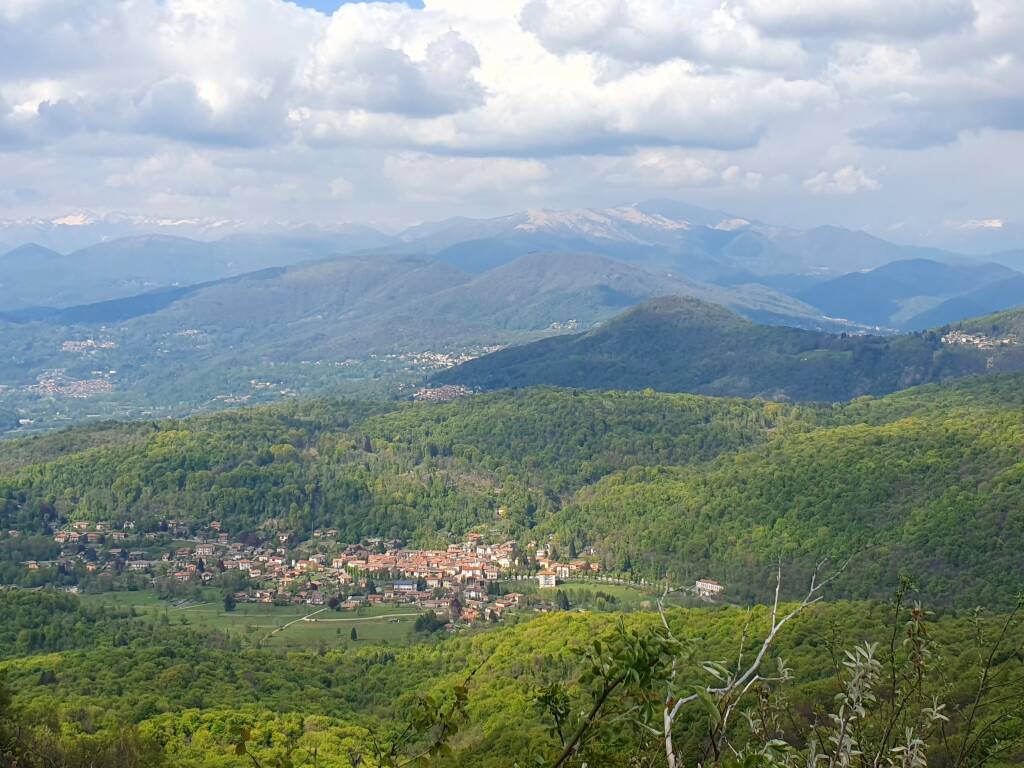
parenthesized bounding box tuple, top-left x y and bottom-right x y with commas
(0, 593, 1022, 768)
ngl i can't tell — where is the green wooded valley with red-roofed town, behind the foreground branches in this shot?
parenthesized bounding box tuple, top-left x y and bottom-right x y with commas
(0, 374, 1024, 768)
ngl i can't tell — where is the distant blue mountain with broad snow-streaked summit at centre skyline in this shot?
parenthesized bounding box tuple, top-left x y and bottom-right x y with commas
(390, 200, 991, 282)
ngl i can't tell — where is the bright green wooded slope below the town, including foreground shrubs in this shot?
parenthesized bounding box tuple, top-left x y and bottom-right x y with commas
(0, 592, 1024, 768)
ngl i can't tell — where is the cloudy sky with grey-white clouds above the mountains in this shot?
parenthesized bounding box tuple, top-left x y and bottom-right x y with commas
(0, 0, 1024, 250)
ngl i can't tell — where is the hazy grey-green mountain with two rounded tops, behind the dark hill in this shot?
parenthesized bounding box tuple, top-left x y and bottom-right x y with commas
(6, 250, 839, 357)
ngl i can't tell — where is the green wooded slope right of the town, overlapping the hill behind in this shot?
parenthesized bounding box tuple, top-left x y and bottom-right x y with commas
(548, 377, 1024, 603)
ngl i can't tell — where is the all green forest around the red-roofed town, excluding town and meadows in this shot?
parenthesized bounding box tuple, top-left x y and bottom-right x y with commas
(0, 374, 1024, 768)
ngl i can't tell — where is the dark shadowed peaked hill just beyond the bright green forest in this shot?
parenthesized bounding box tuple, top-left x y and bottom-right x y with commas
(435, 297, 1024, 401)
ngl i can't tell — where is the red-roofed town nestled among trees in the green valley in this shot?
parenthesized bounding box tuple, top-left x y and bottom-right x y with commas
(6, 519, 724, 629)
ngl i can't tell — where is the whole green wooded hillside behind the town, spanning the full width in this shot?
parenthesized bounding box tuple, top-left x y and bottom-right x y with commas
(0, 375, 1024, 604)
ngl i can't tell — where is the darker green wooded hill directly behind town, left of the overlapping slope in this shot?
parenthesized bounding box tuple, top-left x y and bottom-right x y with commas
(0, 390, 788, 541)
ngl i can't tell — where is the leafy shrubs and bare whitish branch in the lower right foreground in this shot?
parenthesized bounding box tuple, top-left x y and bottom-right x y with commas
(537, 562, 1024, 768)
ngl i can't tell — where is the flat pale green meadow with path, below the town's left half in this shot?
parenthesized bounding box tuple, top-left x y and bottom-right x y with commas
(82, 590, 419, 649)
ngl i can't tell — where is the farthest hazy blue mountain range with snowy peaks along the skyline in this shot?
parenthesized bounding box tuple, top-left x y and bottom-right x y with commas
(0, 201, 1019, 311)
